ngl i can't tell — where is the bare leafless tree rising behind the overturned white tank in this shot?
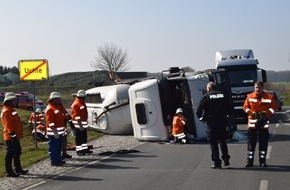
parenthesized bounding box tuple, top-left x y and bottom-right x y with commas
(91, 43, 130, 84)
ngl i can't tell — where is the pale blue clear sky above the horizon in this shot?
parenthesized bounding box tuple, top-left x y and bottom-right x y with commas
(0, 0, 290, 75)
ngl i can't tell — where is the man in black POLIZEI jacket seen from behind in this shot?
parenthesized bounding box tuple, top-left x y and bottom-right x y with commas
(196, 82, 232, 169)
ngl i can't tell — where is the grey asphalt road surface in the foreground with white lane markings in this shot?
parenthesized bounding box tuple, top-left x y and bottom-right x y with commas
(26, 109, 290, 190)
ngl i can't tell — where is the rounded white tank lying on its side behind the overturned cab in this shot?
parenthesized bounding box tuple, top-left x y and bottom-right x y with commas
(85, 84, 133, 135)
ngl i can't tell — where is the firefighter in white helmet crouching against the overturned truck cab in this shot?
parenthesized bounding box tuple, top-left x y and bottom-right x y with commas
(172, 108, 186, 143)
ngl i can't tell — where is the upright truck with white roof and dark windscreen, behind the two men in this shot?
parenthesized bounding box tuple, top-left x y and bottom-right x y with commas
(215, 49, 267, 119)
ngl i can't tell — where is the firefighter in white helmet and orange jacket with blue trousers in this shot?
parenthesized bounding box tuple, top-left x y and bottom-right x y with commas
(45, 92, 65, 166)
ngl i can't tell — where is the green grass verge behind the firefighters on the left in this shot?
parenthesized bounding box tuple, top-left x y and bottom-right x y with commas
(0, 107, 102, 177)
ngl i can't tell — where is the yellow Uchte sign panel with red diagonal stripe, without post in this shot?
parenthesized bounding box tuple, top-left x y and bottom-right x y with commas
(18, 59, 48, 81)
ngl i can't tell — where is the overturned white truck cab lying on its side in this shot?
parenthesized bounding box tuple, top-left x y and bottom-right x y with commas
(129, 68, 236, 141)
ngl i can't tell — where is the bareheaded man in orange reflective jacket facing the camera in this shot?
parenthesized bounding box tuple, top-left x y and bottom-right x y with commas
(243, 81, 277, 167)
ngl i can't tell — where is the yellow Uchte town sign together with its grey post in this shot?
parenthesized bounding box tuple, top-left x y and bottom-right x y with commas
(18, 59, 48, 148)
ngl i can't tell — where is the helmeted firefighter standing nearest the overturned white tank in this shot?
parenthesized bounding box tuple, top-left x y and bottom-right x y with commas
(71, 90, 92, 155)
